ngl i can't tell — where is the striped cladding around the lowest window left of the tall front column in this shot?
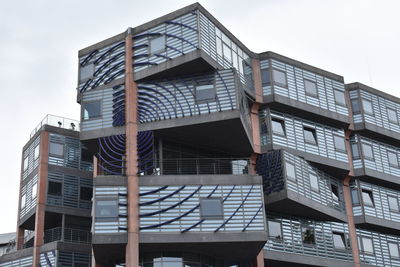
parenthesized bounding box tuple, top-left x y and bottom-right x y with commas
(92, 186, 128, 234)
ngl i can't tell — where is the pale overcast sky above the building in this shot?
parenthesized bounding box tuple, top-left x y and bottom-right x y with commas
(0, 0, 400, 233)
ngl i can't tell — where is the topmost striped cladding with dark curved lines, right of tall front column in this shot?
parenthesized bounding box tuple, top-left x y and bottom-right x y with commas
(133, 11, 199, 72)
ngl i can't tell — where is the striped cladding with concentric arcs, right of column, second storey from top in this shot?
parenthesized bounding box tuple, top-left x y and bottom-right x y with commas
(138, 69, 239, 123)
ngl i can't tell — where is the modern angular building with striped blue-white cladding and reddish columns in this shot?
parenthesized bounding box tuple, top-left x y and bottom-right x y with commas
(0, 3, 400, 267)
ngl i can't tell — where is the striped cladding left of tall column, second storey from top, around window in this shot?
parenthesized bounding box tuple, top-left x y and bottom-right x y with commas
(81, 88, 114, 132)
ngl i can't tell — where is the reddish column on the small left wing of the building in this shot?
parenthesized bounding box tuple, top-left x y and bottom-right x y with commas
(32, 131, 49, 266)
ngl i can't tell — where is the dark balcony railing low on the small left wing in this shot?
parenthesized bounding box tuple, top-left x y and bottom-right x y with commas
(44, 227, 92, 244)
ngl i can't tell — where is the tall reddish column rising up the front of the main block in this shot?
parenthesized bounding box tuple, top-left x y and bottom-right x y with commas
(125, 29, 139, 267)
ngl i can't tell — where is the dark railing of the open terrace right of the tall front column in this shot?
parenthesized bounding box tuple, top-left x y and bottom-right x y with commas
(139, 158, 250, 176)
